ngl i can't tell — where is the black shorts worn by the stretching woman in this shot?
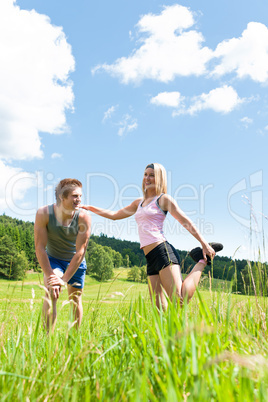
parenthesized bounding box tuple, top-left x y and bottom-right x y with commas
(145, 241, 181, 276)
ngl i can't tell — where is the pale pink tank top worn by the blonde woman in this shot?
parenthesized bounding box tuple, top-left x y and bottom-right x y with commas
(135, 194, 166, 248)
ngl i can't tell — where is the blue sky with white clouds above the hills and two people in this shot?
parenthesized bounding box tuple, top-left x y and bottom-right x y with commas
(0, 0, 268, 260)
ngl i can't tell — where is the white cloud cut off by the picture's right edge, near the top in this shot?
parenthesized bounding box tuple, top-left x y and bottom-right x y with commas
(213, 22, 268, 83)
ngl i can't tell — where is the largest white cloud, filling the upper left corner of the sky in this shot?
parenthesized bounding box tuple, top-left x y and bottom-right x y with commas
(0, 0, 74, 160)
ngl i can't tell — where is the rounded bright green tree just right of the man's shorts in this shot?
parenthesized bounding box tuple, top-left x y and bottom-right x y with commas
(89, 244, 114, 281)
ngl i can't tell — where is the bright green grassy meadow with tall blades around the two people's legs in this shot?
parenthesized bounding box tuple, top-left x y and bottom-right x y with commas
(0, 269, 268, 402)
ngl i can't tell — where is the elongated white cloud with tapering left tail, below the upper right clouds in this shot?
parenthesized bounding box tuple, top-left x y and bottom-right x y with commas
(173, 85, 245, 116)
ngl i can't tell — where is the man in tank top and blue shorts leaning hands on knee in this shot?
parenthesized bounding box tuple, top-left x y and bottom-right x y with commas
(34, 179, 91, 331)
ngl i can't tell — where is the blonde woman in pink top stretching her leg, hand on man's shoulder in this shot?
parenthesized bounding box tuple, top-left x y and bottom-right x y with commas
(82, 163, 222, 309)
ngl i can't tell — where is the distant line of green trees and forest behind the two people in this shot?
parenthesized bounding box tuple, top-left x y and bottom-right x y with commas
(0, 215, 268, 295)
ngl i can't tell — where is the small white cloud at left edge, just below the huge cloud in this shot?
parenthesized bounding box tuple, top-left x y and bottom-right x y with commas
(0, 160, 36, 210)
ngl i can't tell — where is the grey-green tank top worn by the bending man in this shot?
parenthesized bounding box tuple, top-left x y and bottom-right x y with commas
(46, 204, 80, 261)
